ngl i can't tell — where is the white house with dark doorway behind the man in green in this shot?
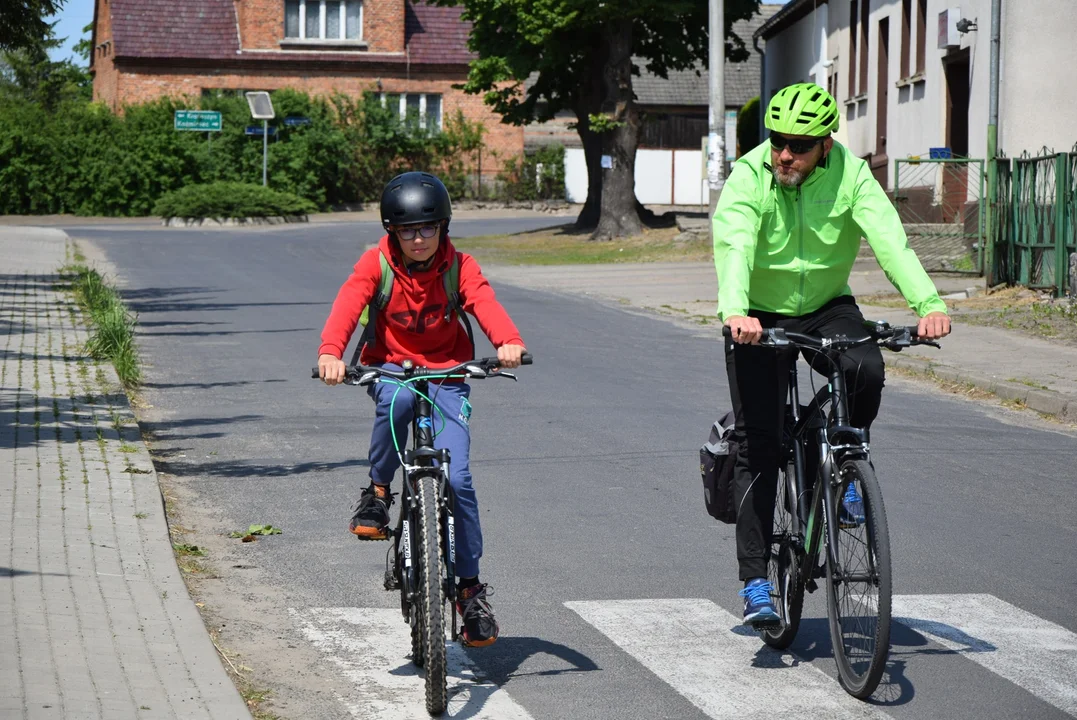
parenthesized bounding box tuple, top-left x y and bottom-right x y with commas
(755, 0, 1077, 188)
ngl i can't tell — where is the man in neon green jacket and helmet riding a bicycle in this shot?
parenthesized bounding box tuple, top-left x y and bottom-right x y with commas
(714, 83, 950, 627)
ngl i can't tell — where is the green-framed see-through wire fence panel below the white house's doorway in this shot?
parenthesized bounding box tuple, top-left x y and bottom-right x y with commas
(893, 157, 985, 274)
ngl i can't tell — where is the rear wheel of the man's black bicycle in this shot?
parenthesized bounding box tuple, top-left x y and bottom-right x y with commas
(759, 463, 805, 650)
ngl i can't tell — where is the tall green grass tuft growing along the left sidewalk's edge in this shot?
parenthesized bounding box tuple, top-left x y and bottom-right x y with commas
(60, 265, 142, 390)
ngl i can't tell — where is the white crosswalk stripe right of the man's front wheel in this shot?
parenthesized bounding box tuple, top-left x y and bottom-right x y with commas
(894, 595, 1077, 716)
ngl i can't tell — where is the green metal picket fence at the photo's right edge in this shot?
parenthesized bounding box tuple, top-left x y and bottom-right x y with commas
(991, 145, 1077, 296)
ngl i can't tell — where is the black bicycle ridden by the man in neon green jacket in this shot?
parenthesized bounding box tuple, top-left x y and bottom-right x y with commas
(725, 322, 939, 700)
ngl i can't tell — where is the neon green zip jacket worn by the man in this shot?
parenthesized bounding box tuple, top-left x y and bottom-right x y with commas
(713, 141, 947, 320)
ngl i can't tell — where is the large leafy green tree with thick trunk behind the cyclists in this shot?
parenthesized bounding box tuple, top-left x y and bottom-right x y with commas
(435, 0, 759, 239)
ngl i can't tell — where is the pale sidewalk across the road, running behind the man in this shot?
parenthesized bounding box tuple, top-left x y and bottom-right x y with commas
(482, 259, 1077, 422)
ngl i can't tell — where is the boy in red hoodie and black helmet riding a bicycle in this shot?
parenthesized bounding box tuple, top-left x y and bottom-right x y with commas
(318, 172, 526, 647)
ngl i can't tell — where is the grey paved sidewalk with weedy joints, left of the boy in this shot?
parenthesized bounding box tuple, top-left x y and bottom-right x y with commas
(0, 227, 251, 720)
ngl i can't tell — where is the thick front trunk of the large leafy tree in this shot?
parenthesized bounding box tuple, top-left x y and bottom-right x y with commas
(591, 19, 643, 240)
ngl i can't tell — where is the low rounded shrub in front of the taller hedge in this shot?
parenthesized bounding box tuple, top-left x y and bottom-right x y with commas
(153, 182, 318, 218)
